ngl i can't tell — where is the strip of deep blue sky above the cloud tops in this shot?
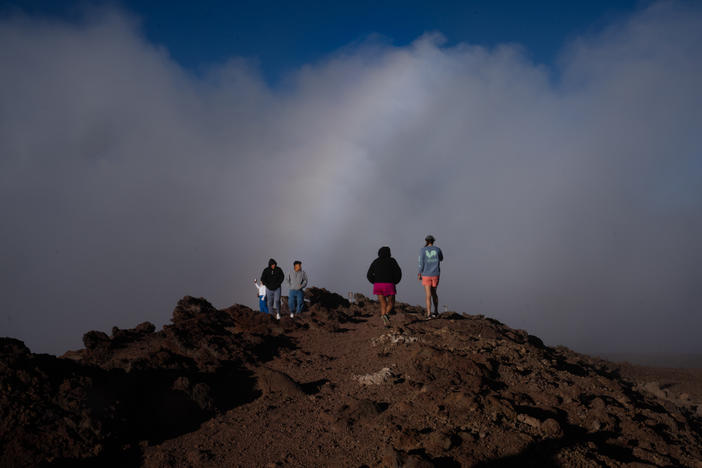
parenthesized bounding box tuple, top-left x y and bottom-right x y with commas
(0, 0, 650, 84)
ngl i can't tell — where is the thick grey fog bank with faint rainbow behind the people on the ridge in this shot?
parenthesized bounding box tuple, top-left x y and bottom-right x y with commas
(0, 2, 702, 354)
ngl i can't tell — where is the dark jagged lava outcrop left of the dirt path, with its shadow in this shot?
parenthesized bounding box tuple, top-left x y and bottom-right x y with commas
(0, 297, 291, 466)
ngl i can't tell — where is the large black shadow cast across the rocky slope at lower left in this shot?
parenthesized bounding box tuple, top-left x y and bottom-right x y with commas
(51, 363, 260, 466)
